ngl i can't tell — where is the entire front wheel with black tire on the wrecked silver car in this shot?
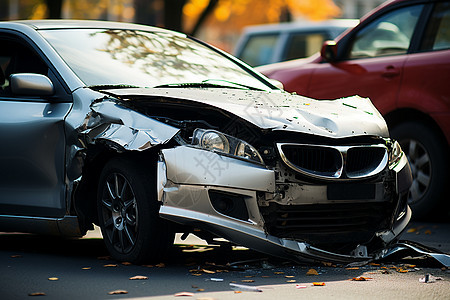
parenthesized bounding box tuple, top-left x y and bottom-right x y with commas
(97, 158, 174, 264)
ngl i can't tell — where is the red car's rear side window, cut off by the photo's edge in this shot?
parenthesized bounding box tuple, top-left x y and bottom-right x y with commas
(420, 2, 450, 51)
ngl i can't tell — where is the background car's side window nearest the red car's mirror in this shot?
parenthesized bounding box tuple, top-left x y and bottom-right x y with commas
(284, 32, 327, 60)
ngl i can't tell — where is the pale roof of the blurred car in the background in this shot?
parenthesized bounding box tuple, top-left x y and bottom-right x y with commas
(244, 19, 359, 34)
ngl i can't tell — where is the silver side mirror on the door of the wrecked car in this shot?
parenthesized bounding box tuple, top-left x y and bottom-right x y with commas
(10, 73, 55, 96)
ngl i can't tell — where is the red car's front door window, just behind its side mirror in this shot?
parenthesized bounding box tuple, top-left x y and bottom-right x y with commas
(350, 5, 423, 58)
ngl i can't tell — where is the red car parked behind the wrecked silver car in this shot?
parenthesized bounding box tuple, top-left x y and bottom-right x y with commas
(258, 0, 450, 218)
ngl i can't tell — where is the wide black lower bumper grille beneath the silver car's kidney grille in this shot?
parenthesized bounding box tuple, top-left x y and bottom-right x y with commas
(260, 202, 392, 245)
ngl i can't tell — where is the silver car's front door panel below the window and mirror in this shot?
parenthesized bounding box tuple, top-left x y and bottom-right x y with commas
(0, 99, 72, 217)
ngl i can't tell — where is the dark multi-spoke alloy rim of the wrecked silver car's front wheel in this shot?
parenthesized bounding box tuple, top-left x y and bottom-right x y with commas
(101, 173, 138, 254)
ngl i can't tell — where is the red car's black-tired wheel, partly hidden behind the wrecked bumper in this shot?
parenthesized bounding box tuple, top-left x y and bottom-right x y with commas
(391, 122, 448, 220)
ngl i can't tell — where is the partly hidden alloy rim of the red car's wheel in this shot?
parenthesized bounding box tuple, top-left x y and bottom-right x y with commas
(400, 139, 432, 204)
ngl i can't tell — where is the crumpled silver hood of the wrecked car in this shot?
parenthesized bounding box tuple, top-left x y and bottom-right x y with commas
(105, 88, 389, 138)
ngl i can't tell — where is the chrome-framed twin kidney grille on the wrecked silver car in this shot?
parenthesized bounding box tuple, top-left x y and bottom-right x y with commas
(277, 143, 388, 179)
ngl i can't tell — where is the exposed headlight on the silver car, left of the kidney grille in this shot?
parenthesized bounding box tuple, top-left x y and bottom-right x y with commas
(192, 128, 264, 164)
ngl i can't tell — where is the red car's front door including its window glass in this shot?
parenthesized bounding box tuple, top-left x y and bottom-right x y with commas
(306, 5, 424, 113)
